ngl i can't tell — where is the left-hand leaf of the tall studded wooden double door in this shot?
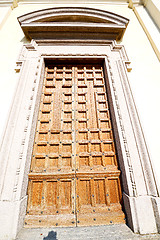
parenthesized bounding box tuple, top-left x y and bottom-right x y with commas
(25, 66, 76, 227)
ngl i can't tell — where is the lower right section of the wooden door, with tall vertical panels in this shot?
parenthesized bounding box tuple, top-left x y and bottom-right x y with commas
(77, 175, 125, 226)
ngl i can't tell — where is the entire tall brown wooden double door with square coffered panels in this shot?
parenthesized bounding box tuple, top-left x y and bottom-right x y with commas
(25, 64, 124, 227)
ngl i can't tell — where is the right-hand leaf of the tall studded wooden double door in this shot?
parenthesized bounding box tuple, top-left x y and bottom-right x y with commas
(75, 66, 124, 225)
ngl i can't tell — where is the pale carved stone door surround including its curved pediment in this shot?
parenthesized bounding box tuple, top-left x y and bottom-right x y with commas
(0, 7, 159, 237)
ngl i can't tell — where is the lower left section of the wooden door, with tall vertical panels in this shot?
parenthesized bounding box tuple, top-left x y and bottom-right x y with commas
(25, 175, 76, 228)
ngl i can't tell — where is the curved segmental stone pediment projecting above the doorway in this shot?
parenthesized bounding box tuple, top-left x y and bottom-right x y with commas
(18, 7, 129, 40)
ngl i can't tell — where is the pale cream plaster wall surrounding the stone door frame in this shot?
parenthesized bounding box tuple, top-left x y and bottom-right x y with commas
(0, 1, 160, 188)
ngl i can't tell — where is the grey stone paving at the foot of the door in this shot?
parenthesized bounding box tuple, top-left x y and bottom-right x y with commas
(16, 224, 160, 240)
